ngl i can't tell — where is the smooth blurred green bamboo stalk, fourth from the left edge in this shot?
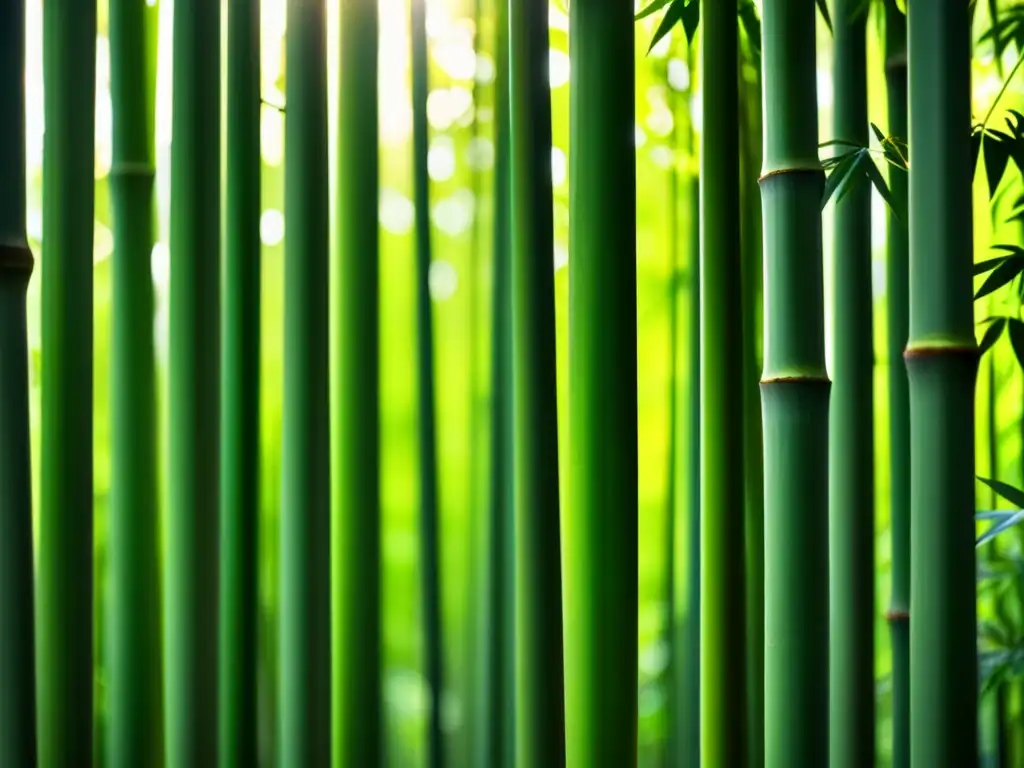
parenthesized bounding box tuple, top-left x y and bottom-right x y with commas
(164, 0, 221, 768)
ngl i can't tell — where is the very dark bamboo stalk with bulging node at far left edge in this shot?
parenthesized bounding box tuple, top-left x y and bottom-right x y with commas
(0, 0, 37, 768)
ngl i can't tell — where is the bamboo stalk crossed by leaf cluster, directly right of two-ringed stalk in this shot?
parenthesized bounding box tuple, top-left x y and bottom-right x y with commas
(828, 0, 874, 768)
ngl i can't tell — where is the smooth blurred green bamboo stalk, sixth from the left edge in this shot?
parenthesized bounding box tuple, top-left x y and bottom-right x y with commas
(278, 0, 329, 768)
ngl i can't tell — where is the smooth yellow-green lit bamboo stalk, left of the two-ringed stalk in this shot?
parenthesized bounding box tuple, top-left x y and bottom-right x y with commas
(700, 0, 748, 766)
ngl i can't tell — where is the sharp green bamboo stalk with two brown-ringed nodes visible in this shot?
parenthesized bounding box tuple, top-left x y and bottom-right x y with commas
(761, 0, 829, 768)
